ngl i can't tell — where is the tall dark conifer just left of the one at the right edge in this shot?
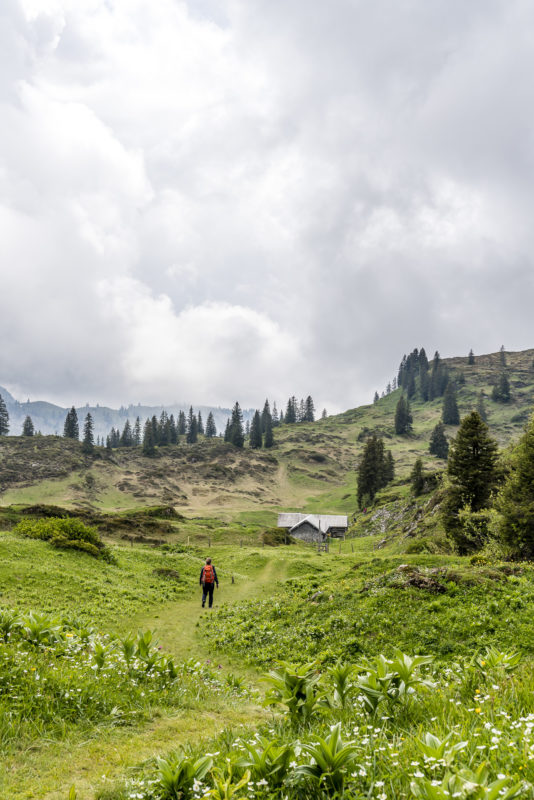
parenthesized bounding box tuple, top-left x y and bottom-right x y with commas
(443, 411, 499, 554)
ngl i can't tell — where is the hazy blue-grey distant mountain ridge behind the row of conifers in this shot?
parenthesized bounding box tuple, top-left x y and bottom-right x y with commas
(0, 386, 255, 438)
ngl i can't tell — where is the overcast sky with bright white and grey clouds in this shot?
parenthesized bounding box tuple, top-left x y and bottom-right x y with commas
(0, 0, 534, 412)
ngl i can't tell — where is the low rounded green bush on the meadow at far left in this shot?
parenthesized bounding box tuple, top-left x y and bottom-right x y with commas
(15, 517, 114, 561)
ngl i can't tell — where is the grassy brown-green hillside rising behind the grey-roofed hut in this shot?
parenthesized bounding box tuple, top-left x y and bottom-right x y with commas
(0, 350, 534, 524)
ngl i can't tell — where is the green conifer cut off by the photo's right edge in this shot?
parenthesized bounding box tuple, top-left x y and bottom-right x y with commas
(498, 416, 534, 560)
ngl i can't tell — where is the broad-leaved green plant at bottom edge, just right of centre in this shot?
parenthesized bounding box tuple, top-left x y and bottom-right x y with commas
(295, 722, 357, 794)
